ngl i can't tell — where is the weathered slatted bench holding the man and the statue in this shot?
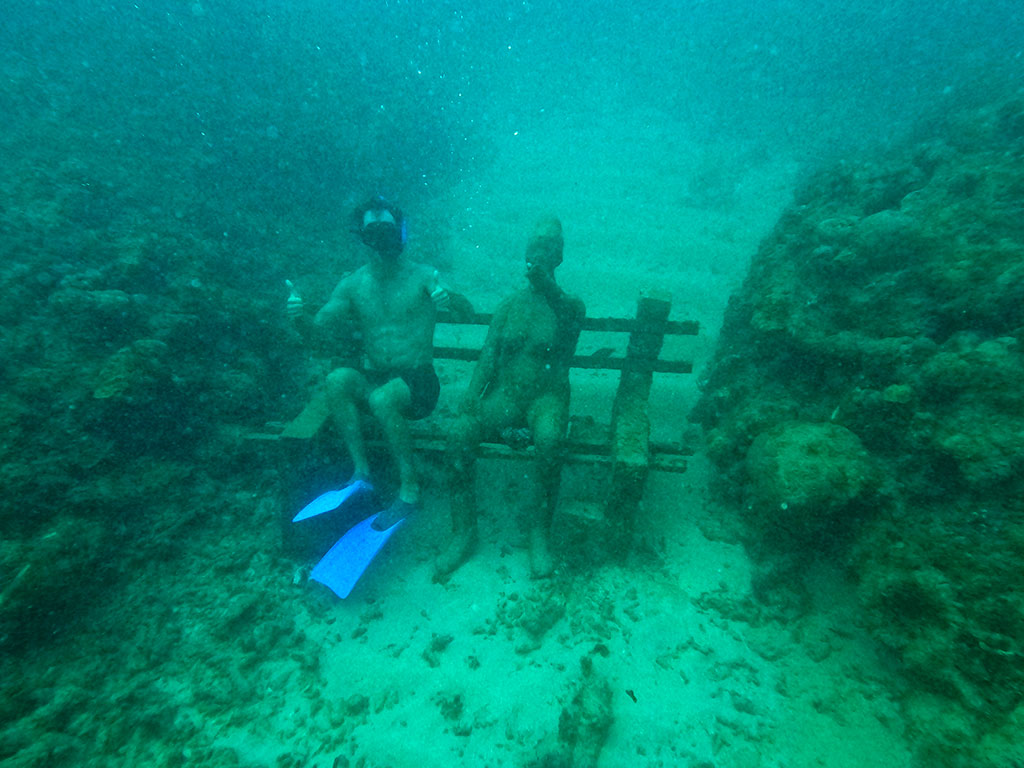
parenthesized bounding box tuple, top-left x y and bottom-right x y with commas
(250, 292, 699, 514)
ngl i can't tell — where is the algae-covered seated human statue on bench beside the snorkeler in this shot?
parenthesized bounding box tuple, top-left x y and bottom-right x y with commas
(435, 217, 586, 580)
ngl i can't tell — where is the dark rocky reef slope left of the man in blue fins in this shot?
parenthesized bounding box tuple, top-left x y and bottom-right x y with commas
(0, 117, 356, 656)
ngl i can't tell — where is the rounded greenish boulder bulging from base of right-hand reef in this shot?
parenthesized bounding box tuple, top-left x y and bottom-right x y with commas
(746, 422, 880, 538)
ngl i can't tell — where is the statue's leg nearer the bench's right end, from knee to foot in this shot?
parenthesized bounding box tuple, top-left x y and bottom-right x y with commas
(527, 395, 568, 579)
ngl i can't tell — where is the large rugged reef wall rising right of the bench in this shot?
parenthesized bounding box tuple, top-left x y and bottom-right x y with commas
(691, 98, 1024, 757)
